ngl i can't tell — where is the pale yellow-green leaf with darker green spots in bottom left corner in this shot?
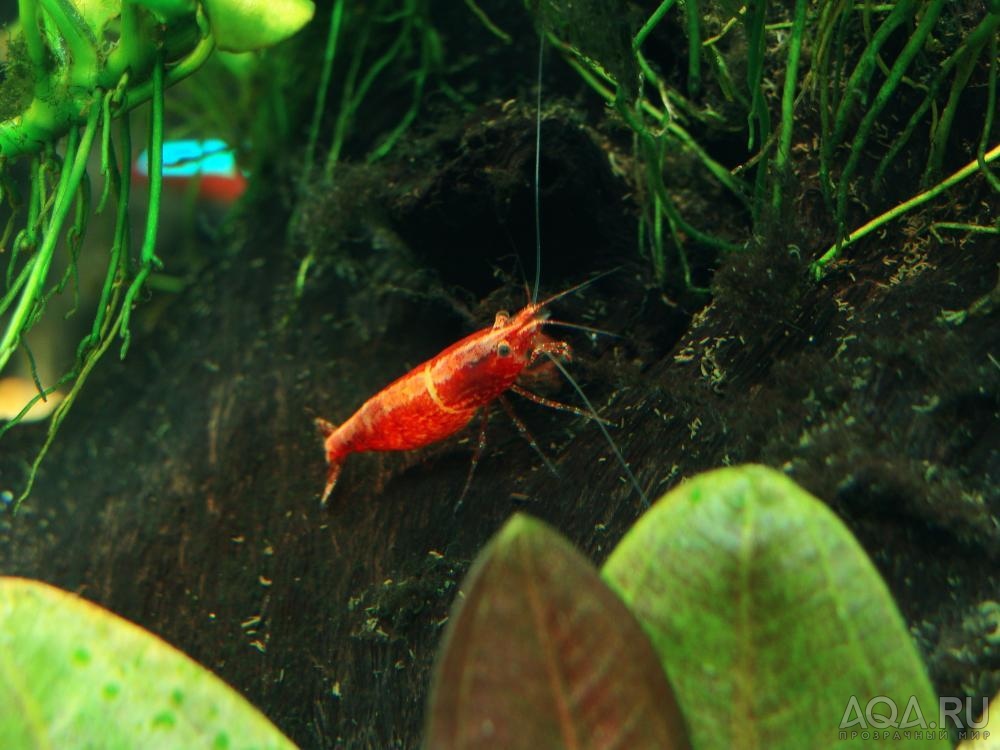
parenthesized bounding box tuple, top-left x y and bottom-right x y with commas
(0, 577, 295, 750)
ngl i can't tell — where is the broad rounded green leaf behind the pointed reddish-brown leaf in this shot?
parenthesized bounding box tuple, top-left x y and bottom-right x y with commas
(603, 466, 949, 750)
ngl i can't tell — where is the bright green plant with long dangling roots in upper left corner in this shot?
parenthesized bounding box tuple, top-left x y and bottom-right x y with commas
(0, 0, 313, 502)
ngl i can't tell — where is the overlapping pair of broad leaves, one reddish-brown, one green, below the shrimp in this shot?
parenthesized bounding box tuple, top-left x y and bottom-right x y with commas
(426, 465, 950, 750)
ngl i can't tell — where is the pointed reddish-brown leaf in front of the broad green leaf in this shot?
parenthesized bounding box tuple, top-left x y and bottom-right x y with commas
(426, 515, 688, 750)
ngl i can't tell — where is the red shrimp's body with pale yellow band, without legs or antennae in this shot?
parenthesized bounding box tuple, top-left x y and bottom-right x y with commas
(316, 302, 570, 503)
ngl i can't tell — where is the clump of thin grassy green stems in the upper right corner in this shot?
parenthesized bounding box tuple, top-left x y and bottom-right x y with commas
(525, 0, 1000, 284)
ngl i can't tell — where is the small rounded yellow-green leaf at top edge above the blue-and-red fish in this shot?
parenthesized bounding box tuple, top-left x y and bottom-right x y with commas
(204, 0, 316, 52)
